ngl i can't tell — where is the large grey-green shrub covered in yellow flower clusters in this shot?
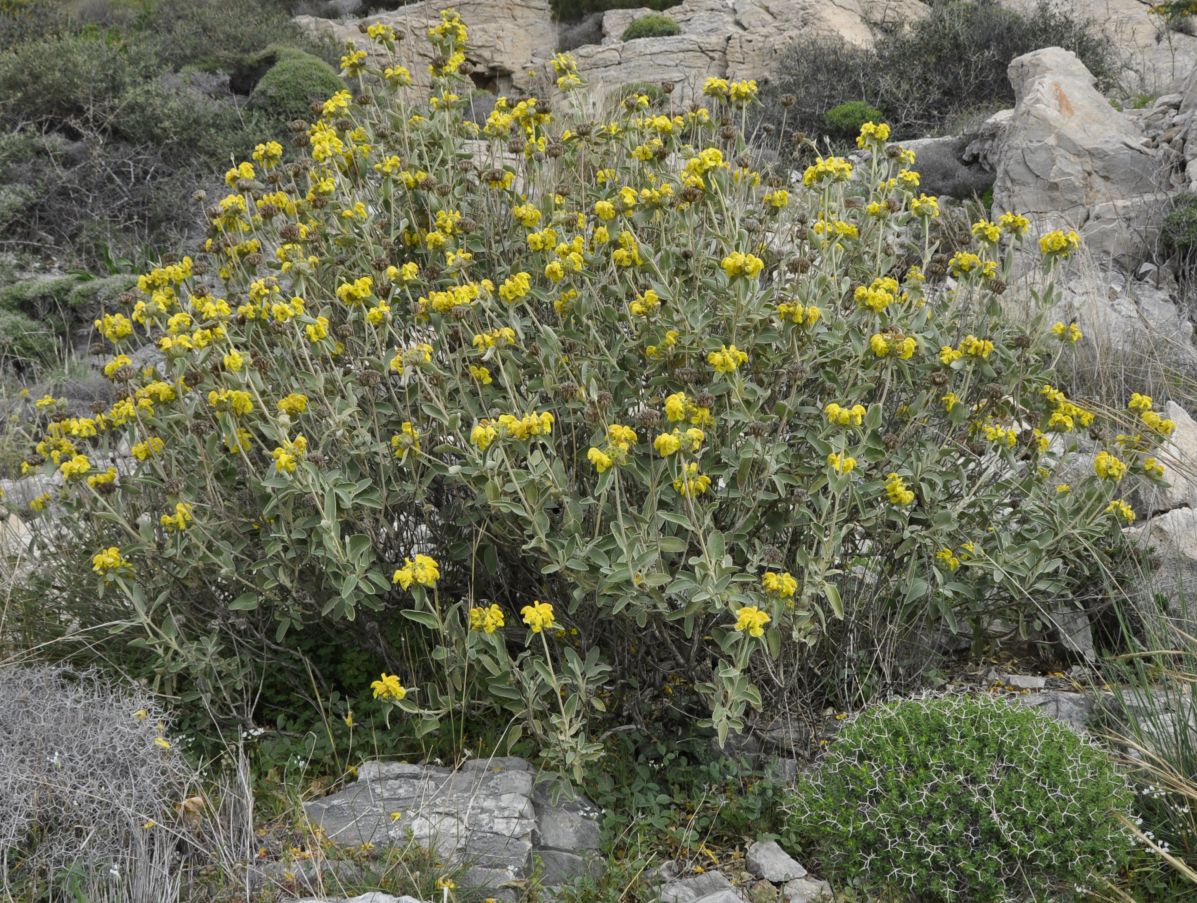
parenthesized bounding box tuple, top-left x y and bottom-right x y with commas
(14, 13, 1172, 772)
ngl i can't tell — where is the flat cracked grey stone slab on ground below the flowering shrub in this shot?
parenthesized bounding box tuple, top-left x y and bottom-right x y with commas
(304, 757, 601, 886)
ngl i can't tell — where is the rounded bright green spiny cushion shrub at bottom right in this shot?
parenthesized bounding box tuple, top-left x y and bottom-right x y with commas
(790, 696, 1132, 903)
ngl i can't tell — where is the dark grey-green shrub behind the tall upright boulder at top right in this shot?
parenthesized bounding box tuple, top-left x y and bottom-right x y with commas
(765, 0, 1120, 144)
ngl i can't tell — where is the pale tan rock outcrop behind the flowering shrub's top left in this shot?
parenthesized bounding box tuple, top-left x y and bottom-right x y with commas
(294, 0, 557, 92)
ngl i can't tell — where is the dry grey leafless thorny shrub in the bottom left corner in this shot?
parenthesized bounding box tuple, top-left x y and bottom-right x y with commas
(0, 666, 192, 899)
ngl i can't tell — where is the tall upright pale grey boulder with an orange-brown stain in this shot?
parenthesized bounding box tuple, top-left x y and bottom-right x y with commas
(994, 47, 1166, 260)
